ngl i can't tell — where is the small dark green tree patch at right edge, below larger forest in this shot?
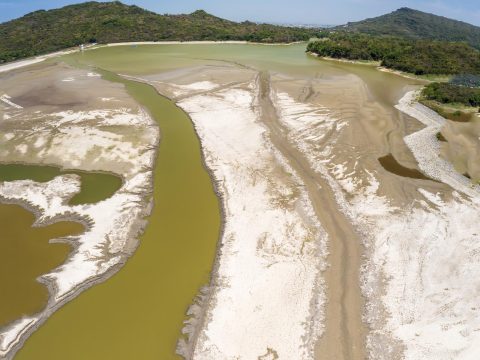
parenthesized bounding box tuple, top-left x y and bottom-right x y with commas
(422, 83, 480, 106)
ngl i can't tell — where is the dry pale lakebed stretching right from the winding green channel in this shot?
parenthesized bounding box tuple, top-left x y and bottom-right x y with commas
(135, 57, 480, 359)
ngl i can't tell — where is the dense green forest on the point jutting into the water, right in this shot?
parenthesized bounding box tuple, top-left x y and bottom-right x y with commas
(308, 32, 480, 75)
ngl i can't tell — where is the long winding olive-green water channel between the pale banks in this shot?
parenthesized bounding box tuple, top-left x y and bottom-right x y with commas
(15, 68, 220, 360)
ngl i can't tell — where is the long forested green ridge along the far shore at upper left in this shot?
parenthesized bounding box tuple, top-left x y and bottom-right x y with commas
(0, 1, 317, 63)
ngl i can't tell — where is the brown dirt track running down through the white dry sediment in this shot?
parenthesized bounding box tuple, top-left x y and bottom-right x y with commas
(258, 72, 366, 360)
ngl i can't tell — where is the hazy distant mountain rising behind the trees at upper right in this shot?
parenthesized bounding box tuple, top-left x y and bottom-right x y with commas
(336, 8, 480, 49)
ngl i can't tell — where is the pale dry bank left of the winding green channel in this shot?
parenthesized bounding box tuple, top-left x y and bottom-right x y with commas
(0, 64, 159, 359)
